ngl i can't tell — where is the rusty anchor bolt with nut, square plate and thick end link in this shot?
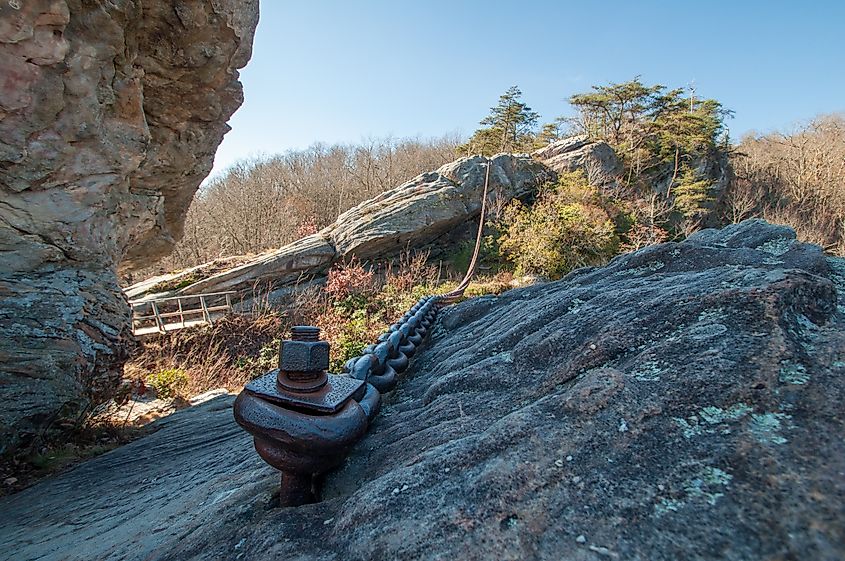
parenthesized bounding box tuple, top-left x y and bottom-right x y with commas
(234, 326, 381, 506)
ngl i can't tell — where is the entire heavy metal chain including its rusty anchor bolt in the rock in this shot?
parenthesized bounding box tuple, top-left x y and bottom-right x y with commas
(233, 156, 490, 506)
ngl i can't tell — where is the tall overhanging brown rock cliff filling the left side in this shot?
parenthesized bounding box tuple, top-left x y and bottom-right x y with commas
(0, 0, 258, 449)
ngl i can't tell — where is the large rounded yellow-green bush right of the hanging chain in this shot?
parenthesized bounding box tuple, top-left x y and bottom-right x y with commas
(499, 168, 619, 279)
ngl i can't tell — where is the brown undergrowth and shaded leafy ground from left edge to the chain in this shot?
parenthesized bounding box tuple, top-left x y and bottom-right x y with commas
(0, 253, 514, 496)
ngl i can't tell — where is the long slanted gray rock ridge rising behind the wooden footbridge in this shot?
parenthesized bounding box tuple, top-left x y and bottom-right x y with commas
(126, 154, 552, 299)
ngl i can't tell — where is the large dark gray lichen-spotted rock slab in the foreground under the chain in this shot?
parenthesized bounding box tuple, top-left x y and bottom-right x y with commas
(0, 221, 845, 561)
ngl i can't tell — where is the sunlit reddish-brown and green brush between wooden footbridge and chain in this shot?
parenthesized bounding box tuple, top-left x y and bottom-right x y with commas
(124, 252, 512, 397)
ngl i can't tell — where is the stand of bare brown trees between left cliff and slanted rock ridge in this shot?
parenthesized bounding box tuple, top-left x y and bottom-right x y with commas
(133, 132, 460, 279)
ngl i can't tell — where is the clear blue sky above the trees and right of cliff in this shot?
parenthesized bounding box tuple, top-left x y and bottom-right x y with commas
(208, 0, 845, 177)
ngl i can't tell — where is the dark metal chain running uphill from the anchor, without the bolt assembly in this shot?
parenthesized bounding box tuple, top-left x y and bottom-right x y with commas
(343, 159, 491, 393)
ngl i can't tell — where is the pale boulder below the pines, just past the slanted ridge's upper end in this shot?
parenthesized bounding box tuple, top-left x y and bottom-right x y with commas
(531, 134, 622, 187)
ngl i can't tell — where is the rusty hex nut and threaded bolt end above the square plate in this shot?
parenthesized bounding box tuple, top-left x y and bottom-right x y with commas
(278, 325, 329, 392)
